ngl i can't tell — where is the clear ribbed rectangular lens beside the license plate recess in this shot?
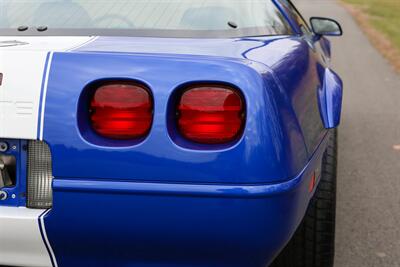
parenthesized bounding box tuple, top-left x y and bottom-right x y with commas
(27, 141, 53, 209)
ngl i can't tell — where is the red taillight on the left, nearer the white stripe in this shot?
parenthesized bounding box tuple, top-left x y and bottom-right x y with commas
(90, 83, 153, 140)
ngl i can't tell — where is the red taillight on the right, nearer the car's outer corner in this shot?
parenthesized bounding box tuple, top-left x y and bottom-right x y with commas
(178, 86, 244, 144)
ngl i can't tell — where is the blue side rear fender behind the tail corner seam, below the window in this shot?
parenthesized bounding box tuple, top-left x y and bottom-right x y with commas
(247, 37, 327, 156)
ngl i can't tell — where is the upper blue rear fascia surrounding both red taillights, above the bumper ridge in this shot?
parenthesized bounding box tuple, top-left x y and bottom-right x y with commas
(44, 49, 307, 184)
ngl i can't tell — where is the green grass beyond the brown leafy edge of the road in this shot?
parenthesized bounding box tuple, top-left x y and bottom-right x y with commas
(344, 0, 400, 50)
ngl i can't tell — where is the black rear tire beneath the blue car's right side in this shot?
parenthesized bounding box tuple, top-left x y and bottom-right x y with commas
(270, 130, 337, 267)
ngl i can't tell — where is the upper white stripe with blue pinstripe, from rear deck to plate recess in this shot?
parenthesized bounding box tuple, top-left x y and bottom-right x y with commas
(0, 37, 95, 139)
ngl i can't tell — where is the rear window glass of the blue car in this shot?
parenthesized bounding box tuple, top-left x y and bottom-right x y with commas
(0, 0, 290, 37)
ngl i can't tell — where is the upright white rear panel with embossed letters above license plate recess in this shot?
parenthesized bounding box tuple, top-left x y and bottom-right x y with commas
(0, 50, 47, 139)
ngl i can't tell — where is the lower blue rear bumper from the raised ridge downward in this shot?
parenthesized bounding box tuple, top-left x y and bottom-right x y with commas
(45, 134, 326, 267)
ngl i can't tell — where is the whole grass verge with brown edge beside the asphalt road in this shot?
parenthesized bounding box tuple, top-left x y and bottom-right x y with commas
(342, 0, 400, 72)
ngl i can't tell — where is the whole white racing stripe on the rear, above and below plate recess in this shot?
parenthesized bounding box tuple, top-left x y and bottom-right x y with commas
(0, 37, 95, 267)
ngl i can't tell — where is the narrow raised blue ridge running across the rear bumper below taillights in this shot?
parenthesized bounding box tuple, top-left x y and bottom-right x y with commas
(53, 136, 327, 198)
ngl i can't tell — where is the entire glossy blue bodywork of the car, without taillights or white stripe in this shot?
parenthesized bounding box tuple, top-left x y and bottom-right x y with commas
(0, 1, 342, 267)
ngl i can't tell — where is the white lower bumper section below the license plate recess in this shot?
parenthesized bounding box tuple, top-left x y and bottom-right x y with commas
(0, 206, 52, 267)
